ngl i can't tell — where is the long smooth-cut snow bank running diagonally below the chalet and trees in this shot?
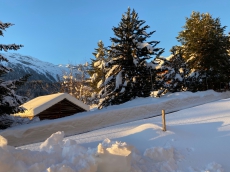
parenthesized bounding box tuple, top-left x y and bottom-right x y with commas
(0, 90, 230, 146)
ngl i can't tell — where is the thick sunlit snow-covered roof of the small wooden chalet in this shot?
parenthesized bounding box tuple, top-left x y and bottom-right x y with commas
(14, 93, 89, 117)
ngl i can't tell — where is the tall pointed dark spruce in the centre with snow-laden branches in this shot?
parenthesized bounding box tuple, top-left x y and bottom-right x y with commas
(99, 8, 164, 108)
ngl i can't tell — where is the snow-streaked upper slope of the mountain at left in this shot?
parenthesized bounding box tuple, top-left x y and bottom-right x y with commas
(0, 53, 89, 82)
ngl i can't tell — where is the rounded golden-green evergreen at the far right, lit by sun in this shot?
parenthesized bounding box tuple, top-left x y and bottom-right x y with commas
(177, 12, 230, 91)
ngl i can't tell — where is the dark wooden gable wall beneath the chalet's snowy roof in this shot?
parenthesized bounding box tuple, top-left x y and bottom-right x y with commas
(37, 99, 86, 120)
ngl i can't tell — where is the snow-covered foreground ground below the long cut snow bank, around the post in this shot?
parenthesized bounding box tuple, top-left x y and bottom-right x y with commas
(0, 92, 230, 172)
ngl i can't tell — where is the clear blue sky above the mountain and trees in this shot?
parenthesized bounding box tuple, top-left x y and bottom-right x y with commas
(0, 0, 230, 64)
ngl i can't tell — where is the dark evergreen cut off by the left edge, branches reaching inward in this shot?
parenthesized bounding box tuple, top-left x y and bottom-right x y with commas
(0, 21, 29, 129)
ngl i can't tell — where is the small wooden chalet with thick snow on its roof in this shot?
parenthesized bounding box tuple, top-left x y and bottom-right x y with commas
(14, 93, 89, 120)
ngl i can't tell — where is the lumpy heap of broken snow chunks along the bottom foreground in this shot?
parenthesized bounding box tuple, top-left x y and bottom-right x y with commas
(0, 131, 174, 172)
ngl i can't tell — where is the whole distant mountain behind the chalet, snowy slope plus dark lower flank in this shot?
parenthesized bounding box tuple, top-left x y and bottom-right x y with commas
(0, 53, 89, 99)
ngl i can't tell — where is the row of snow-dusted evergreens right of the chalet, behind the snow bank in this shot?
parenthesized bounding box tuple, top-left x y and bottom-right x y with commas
(69, 8, 230, 109)
